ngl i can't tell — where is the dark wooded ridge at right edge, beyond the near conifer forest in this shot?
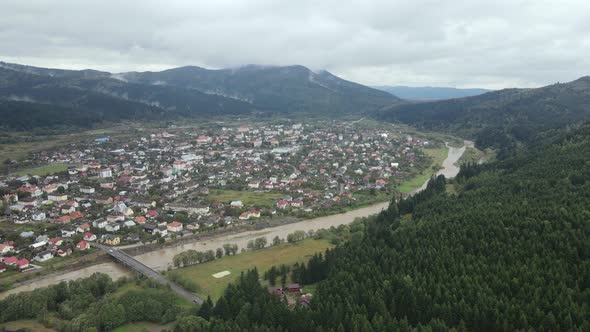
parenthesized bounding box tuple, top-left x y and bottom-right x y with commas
(374, 76, 590, 152)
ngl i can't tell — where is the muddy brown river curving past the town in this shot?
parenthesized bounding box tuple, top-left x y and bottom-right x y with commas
(0, 141, 473, 299)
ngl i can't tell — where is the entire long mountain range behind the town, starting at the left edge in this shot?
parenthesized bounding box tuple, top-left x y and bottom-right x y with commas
(0, 62, 399, 130)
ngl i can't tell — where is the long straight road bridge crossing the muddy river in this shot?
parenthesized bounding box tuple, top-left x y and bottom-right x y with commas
(90, 242, 203, 304)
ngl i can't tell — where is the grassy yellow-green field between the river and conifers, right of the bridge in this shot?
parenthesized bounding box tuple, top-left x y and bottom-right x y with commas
(172, 239, 333, 300)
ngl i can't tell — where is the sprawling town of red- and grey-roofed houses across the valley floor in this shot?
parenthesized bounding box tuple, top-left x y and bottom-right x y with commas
(0, 121, 442, 273)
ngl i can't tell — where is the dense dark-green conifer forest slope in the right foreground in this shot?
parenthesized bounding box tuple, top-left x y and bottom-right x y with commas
(177, 126, 590, 331)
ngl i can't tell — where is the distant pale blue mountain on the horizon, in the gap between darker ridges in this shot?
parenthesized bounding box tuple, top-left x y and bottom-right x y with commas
(374, 85, 492, 100)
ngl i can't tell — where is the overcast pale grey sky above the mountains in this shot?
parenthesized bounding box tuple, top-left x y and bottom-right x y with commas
(0, 0, 590, 89)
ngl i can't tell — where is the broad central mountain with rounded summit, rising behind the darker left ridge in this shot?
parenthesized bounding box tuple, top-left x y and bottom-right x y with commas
(119, 65, 399, 114)
